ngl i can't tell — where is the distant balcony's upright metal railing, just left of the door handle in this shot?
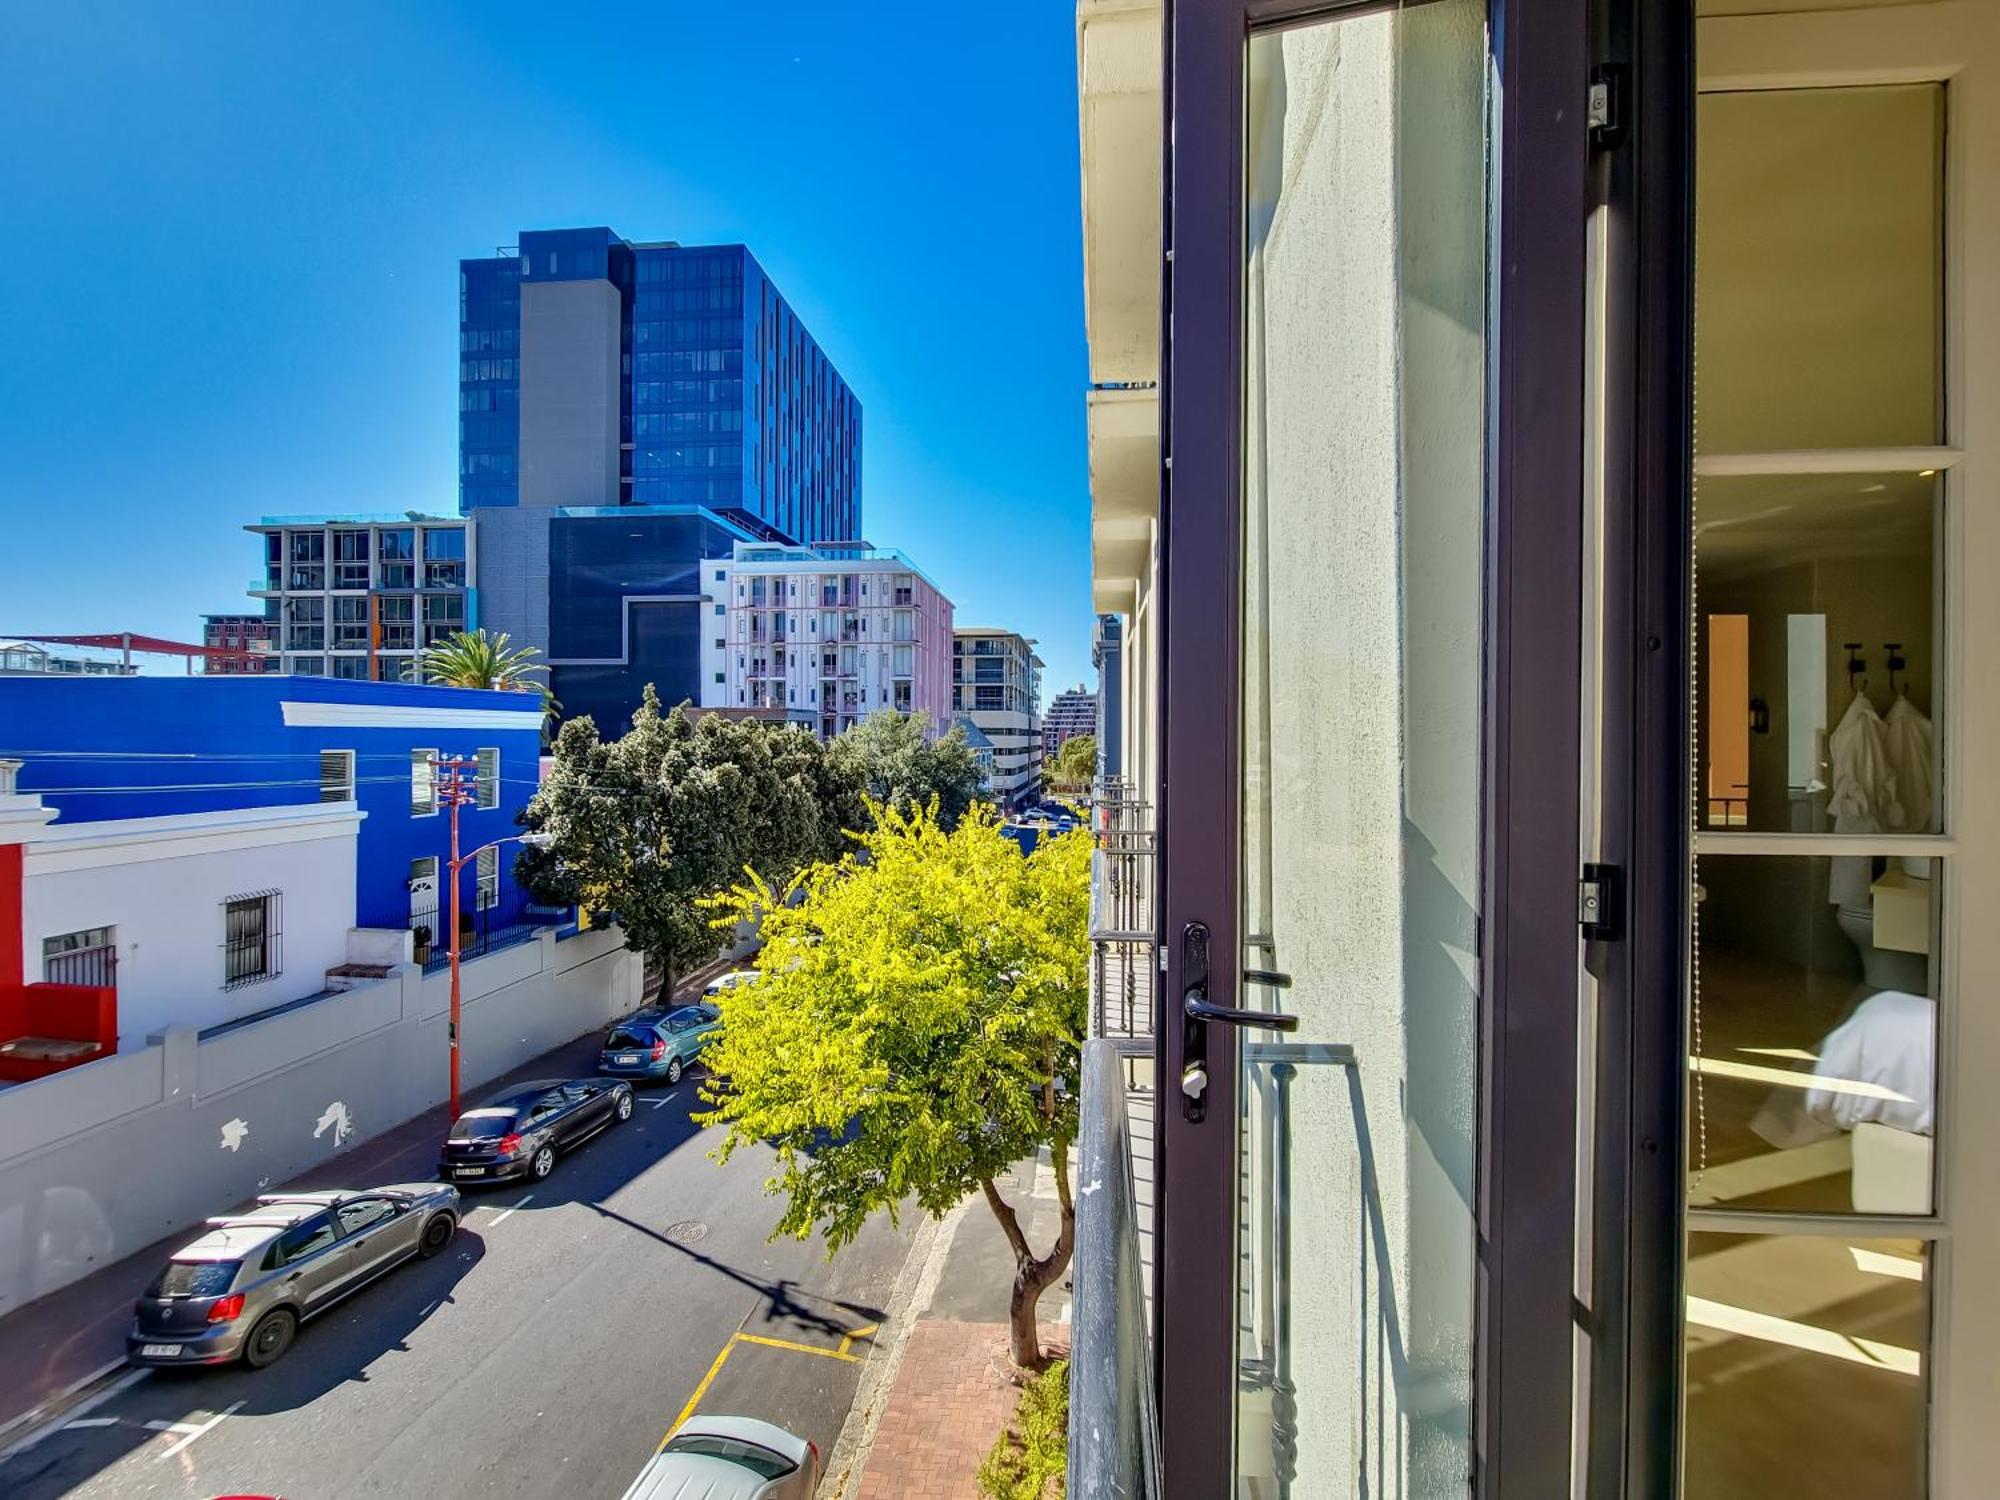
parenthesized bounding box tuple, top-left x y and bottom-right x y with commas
(1090, 776, 1156, 1038)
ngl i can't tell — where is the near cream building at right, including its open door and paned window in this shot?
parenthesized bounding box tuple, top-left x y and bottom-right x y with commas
(1068, 0, 2000, 1500)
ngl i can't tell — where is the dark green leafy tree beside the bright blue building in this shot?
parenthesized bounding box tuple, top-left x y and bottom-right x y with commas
(516, 686, 866, 994)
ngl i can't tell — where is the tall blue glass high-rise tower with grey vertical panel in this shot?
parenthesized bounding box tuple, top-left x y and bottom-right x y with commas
(458, 228, 862, 732)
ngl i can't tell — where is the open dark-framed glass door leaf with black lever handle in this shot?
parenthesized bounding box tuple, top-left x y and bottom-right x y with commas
(1156, 0, 1588, 1500)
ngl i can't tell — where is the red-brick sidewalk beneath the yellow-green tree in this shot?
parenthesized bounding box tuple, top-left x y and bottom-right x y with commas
(828, 1160, 1070, 1500)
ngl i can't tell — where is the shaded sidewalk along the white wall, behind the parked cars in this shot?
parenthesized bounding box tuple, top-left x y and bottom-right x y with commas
(0, 960, 742, 1446)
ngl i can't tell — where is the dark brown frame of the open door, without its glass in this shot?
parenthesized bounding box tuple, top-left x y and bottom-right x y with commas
(1156, 0, 1592, 1500)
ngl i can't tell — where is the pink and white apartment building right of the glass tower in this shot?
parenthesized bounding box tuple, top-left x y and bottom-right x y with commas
(702, 542, 952, 740)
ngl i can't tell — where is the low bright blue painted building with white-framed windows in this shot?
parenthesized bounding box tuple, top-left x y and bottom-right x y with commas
(0, 674, 542, 932)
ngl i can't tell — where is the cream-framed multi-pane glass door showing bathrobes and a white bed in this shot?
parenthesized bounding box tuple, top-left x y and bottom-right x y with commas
(1682, 6, 2000, 1500)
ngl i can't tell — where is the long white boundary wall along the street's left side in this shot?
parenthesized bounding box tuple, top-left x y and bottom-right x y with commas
(0, 928, 642, 1314)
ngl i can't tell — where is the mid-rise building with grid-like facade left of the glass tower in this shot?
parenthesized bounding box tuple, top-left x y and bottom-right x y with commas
(244, 512, 474, 682)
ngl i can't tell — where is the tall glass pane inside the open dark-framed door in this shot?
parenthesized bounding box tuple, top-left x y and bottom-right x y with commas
(1234, 0, 1486, 1500)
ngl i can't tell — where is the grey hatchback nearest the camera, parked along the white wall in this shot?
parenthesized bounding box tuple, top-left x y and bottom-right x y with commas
(126, 1182, 458, 1370)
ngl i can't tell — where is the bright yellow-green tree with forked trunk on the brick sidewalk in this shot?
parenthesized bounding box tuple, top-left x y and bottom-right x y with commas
(704, 806, 1090, 1368)
